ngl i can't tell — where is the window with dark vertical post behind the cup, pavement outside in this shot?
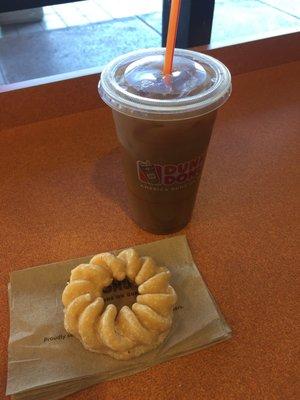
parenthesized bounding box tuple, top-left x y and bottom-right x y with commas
(0, 0, 300, 85)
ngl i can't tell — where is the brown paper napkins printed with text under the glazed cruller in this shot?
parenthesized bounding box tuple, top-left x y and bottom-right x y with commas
(6, 236, 230, 400)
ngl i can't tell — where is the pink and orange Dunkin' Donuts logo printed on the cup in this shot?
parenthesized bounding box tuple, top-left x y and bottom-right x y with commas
(137, 155, 204, 186)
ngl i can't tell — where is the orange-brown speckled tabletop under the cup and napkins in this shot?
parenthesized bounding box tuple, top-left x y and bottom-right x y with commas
(0, 63, 300, 400)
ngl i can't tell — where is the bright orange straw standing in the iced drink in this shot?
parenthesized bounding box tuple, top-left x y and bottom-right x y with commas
(163, 0, 181, 75)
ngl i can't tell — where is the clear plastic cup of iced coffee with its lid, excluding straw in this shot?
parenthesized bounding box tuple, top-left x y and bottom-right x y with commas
(99, 48, 231, 234)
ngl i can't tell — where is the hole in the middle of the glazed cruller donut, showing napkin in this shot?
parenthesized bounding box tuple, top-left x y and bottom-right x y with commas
(102, 278, 138, 311)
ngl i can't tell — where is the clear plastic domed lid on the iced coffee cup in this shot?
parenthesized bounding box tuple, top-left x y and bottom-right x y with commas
(98, 48, 231, 120)
